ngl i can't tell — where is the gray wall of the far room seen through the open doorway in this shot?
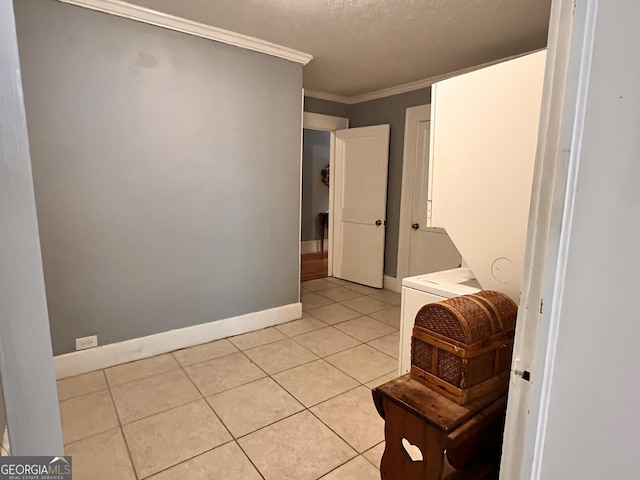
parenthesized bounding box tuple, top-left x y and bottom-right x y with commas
(301, 129, 330, 242)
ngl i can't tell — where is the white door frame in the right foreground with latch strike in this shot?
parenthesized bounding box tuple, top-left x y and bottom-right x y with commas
(500, 0, 598, 480)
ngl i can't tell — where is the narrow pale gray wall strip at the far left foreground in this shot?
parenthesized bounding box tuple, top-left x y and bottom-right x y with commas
(0, 0, 63, 455)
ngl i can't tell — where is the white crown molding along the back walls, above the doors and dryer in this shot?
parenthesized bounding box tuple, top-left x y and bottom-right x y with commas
(305, 50, 538, 105)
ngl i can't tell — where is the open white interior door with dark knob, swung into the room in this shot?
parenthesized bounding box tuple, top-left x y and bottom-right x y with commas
(332, 125, 389, 288)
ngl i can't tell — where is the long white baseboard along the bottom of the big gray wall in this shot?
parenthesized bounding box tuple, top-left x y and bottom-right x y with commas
(54, 303, 302, 379)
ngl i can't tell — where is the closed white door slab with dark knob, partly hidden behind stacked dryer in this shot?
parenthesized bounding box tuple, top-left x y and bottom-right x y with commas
(402, 115, 461, 277)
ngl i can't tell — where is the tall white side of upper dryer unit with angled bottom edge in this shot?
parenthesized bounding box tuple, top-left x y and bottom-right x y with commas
(429, 52, 546, 302)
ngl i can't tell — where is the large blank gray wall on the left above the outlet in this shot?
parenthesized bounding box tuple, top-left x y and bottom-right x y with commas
(16, 0, 302, 354)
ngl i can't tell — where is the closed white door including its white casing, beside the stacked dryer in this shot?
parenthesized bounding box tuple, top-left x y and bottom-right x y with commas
(397, 105, 461, 278)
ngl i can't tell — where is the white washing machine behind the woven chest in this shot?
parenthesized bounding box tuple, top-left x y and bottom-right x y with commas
(398, 267, 481, 375)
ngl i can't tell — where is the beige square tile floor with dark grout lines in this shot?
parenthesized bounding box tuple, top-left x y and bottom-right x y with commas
(58, 278, 400, 480)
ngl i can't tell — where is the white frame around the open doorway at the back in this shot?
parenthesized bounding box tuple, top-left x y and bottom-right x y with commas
(298, 112, 349, 276)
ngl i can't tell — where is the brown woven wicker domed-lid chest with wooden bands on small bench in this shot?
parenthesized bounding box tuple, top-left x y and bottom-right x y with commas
(411, 291, 518, 405)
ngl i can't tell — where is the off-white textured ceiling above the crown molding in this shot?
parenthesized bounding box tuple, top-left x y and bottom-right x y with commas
(124, 0, 551, 97)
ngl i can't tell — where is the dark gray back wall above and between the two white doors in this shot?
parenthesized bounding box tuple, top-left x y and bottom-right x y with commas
(349, 88, 431, 277)
